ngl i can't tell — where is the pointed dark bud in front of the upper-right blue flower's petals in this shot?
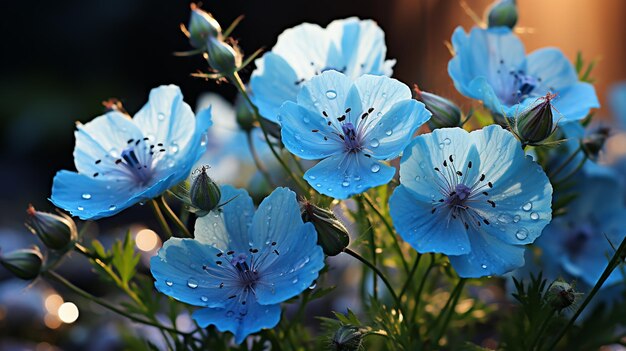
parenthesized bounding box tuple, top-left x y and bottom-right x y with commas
(515, 93, 556, 145)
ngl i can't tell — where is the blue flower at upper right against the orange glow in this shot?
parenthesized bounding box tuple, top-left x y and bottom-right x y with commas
(448, 27, 600, 121)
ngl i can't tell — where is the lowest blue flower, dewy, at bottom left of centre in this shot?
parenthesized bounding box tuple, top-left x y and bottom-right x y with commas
(150, 186, 324, 343)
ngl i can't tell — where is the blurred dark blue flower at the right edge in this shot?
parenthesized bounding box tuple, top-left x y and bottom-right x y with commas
(536, 172, 626, 286)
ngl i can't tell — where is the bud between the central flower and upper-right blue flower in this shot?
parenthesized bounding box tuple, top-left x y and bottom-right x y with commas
(413, 84, 461, 130)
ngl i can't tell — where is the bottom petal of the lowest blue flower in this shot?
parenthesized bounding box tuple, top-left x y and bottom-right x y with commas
(193, 299, 281, 344)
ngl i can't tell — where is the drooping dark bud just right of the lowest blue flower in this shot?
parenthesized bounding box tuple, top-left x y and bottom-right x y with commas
(301, 201, 350, 256)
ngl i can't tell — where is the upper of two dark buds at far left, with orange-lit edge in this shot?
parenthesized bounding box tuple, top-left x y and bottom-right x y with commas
(26, 205, 78, 250)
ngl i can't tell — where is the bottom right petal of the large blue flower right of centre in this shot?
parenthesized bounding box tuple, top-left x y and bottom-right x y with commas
(448, 227, 525, 278)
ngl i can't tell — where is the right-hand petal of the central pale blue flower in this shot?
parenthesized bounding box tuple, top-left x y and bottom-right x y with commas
(364, 99, 431, 159)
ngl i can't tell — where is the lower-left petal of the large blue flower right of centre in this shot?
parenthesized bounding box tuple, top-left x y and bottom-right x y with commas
(389, 185, 470, 255)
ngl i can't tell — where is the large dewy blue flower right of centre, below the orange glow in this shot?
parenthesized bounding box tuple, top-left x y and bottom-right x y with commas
(389, 125, 552, 277)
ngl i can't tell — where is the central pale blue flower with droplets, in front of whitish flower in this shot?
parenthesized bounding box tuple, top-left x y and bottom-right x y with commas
(279, 71, 430, 199)
